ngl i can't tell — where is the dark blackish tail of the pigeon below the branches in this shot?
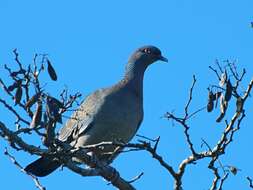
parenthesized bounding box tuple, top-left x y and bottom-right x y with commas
(25, 157, 61, 177)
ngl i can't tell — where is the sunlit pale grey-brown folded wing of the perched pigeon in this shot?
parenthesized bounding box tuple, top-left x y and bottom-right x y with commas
(58, 89, 105, 141)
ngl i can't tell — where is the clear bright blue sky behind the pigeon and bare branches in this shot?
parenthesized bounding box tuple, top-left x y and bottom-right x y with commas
(0, 0, 253, 190)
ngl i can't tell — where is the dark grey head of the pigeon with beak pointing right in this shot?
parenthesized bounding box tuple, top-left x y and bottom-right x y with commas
(129, 45, 168, 66)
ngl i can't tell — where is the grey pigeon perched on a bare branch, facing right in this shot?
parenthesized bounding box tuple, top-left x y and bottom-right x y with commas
(25, 45, 168, 177)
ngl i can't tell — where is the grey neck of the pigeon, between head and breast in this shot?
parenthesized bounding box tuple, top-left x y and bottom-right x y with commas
(123, 61, 147, 98)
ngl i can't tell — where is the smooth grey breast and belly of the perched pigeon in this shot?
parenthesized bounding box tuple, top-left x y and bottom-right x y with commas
(83, 90, 143, 144)
